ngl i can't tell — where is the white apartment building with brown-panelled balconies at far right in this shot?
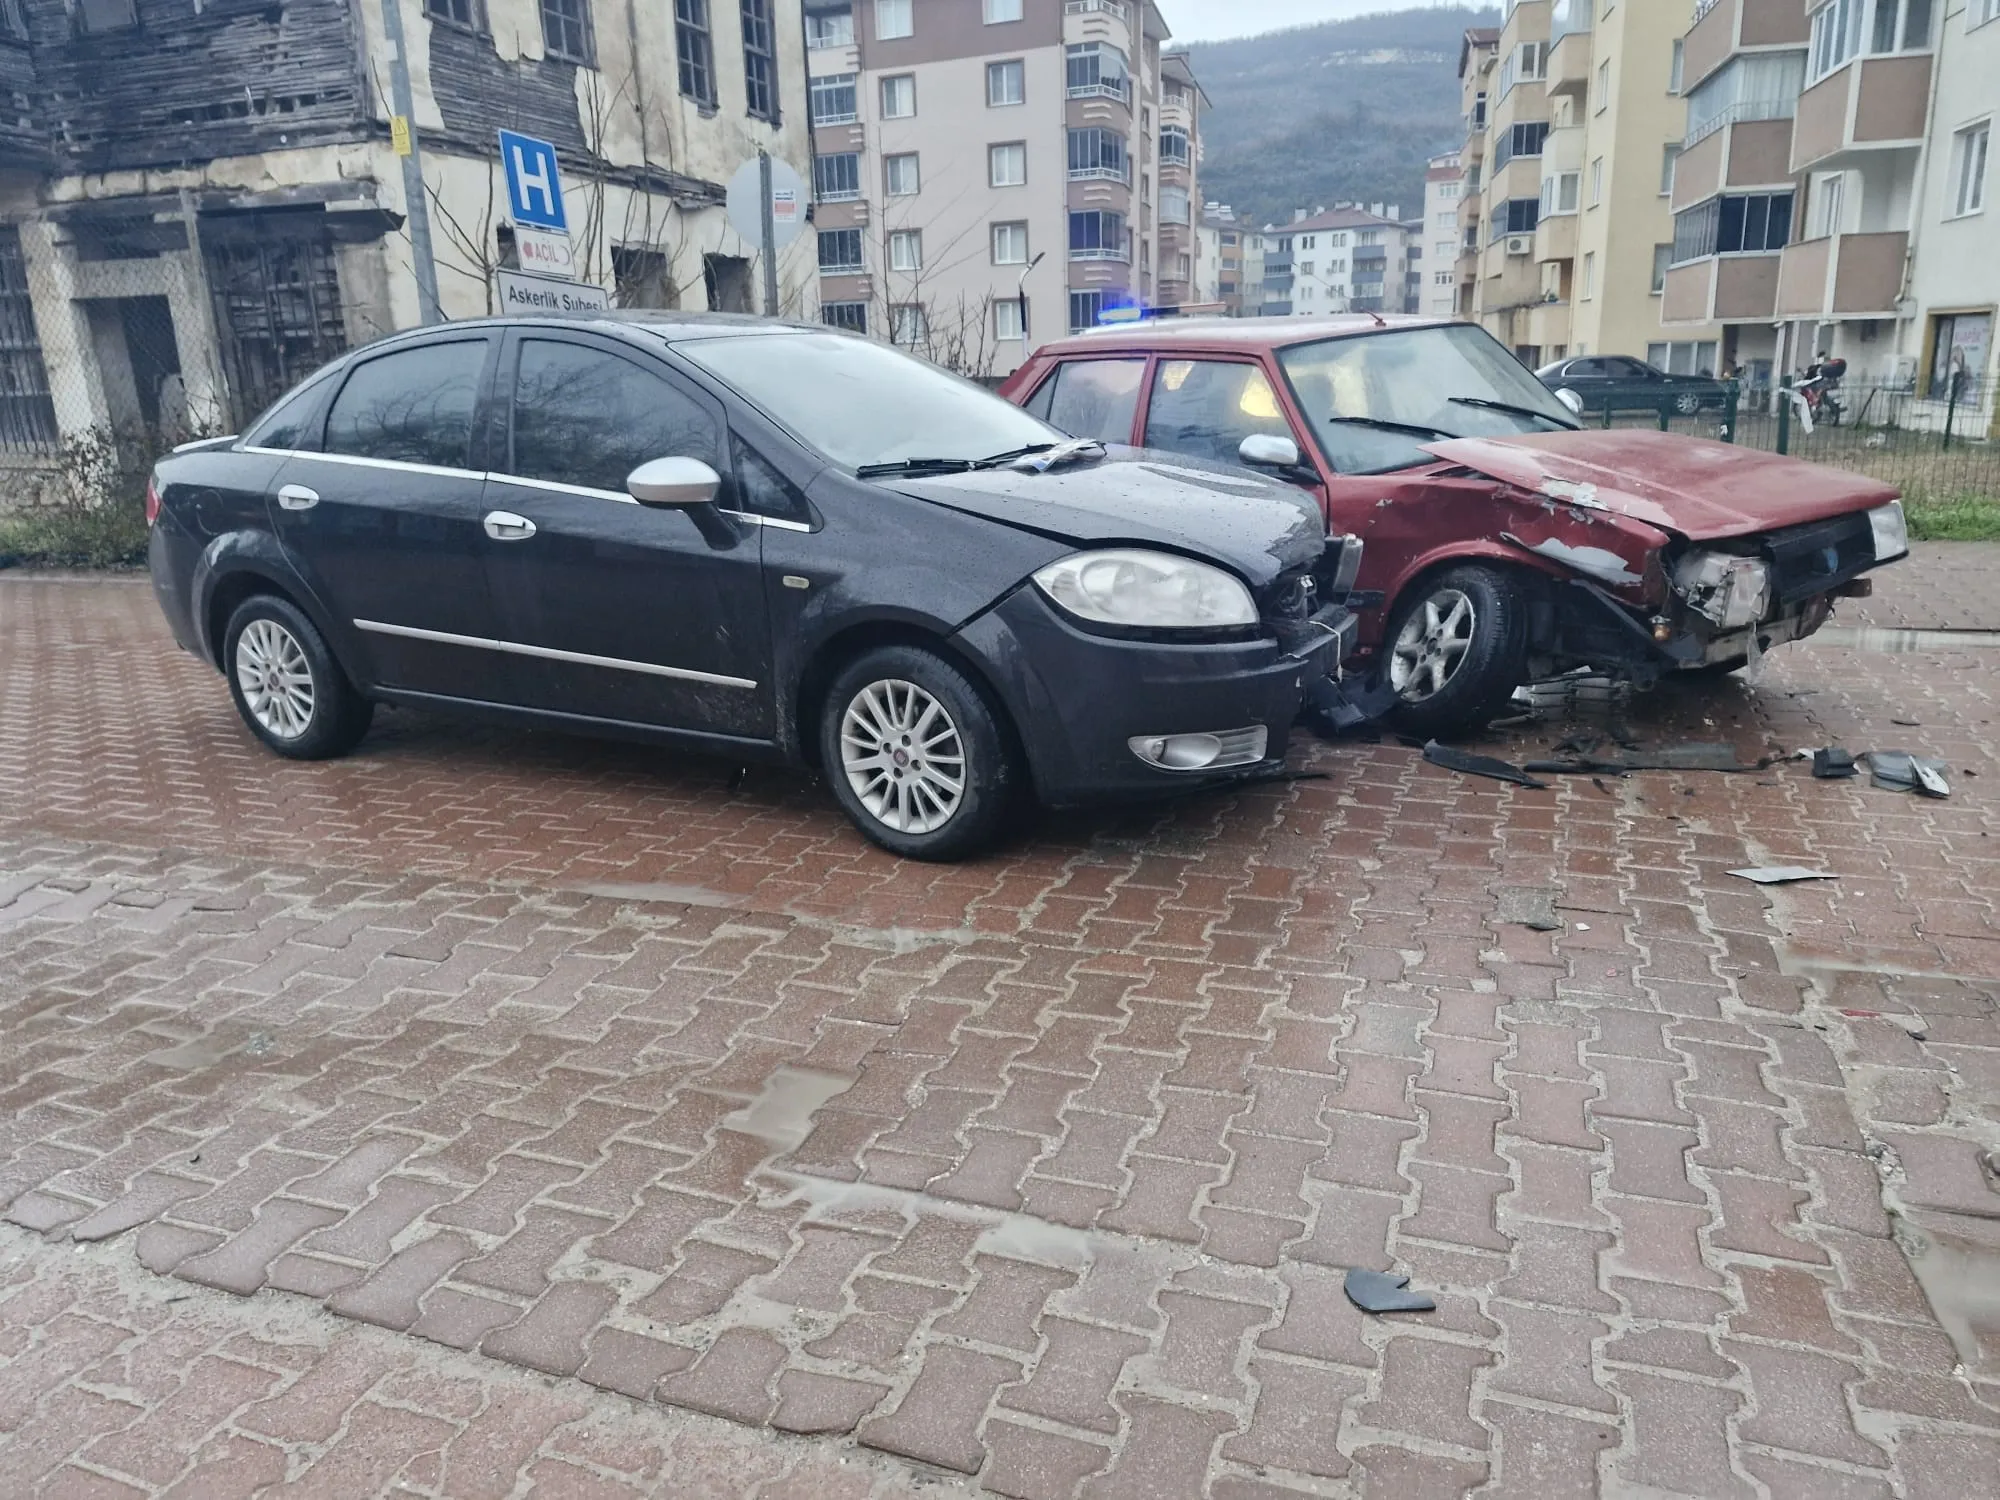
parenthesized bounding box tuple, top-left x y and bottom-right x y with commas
(1666, 0, 2000, 424)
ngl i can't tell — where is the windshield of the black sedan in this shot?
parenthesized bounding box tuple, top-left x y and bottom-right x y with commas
(674, 332, 1062, 468)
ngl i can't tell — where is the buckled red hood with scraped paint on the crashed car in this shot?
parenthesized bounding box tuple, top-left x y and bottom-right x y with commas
(1424, 428, 1896, 542)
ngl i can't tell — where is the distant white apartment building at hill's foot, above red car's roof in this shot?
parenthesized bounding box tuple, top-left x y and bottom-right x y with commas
(1260, 204, 1424, 318)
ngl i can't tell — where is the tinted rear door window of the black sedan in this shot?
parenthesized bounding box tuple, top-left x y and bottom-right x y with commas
(326, 338, 486, 468)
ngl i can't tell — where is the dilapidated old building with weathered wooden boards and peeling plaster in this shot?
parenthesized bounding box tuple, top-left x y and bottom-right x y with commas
(0, 0, 816, 464)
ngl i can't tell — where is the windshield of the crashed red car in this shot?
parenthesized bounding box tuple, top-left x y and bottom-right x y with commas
(1278, 324, 1576, 474)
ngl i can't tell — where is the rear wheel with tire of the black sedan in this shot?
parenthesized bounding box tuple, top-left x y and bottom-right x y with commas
(222, 594, 374, 760)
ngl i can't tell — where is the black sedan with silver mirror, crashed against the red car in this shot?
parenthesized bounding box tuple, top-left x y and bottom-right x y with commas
(148, 314, 1354, 858)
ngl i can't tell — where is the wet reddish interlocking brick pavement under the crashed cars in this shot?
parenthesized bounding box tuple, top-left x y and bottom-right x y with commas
(0, 568, 2000, 1500)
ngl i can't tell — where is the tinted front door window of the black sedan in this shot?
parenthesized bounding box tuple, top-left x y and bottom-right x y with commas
(508, 338, 726, 494)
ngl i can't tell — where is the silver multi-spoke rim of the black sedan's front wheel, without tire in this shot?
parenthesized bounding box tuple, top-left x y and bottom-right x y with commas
(840, 678, 966, 834)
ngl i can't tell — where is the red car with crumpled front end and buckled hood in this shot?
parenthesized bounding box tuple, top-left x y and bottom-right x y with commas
(1002, 314, 1908, 734)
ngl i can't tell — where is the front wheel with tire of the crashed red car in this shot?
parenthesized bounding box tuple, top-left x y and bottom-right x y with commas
(1382, 564, 1528, 734)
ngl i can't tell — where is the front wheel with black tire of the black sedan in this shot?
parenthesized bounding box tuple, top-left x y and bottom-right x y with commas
(820, 646, 1024, 860)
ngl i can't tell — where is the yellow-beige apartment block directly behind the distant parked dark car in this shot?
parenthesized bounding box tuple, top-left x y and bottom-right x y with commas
(1458, 0, 1720, 372)
